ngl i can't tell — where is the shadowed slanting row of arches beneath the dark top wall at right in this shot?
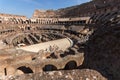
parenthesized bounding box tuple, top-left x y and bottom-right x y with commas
(88, 11, 120, 27)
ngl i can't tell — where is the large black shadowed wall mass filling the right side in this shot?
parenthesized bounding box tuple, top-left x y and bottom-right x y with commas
(81, 25, 120, 80)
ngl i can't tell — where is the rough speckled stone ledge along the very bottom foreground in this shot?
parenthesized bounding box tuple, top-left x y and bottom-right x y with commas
(4, 69, 107, 80)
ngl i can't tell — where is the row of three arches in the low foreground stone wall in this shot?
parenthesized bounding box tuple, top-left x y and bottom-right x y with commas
(4, 60, 78, 76)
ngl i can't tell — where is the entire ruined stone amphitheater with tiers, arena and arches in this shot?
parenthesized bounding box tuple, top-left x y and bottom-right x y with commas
(0, 0, 120, 80)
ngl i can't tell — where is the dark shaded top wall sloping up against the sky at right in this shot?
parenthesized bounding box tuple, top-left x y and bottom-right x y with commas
(54, 0, 120, 17)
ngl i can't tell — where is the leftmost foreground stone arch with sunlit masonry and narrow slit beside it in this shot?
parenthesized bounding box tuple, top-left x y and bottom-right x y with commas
(4, 63, 35, 75)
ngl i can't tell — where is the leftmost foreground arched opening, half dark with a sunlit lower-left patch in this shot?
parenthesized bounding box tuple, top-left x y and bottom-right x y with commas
(16, 66, 33, 74)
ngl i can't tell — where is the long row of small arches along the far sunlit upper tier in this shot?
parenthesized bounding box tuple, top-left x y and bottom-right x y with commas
(0, 18, 87, 25)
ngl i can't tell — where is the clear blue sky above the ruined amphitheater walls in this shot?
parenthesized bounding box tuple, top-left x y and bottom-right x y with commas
(0, 0, 90, 17)
